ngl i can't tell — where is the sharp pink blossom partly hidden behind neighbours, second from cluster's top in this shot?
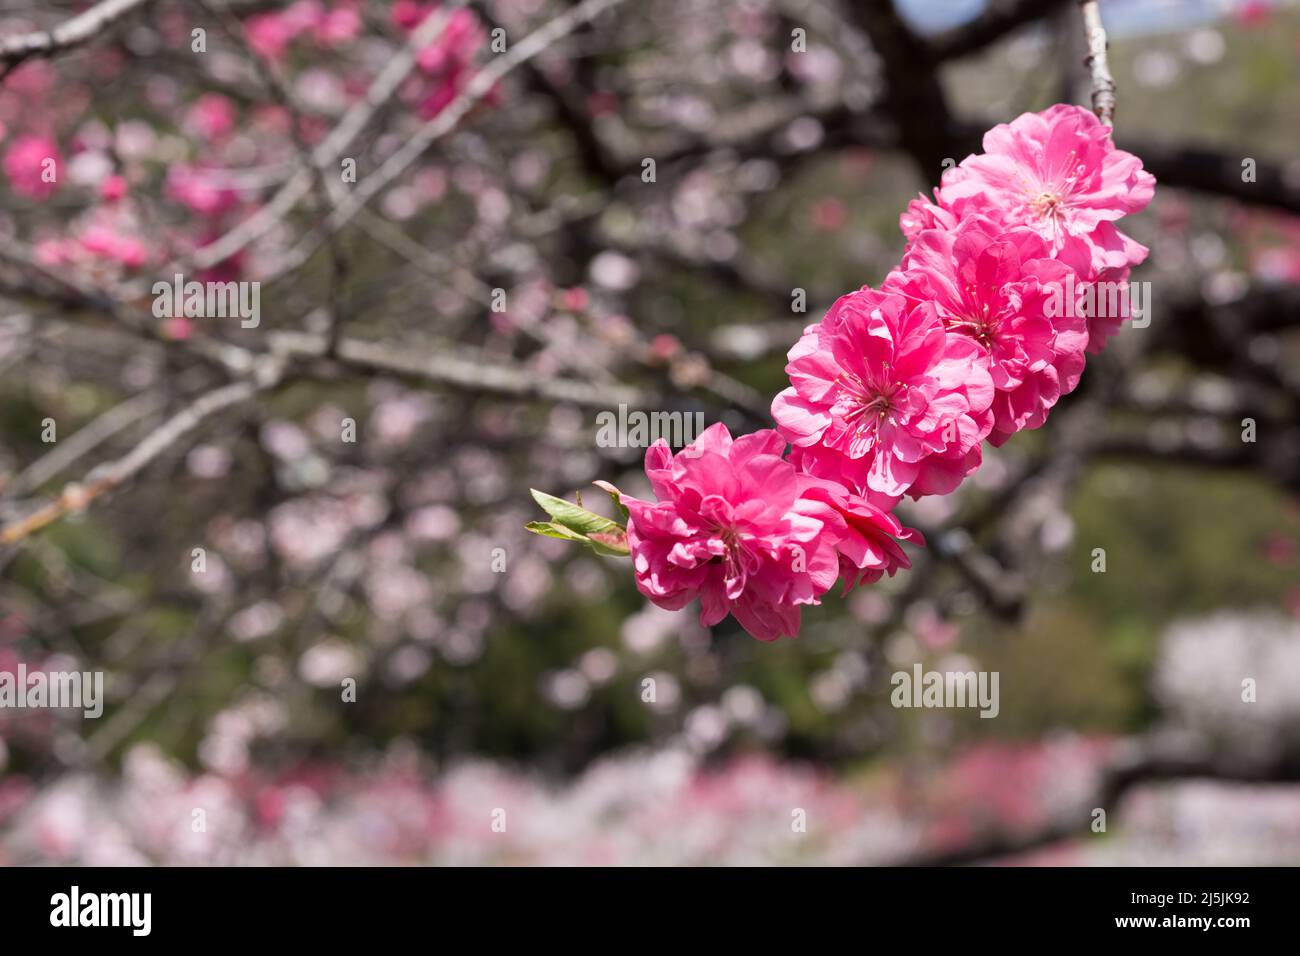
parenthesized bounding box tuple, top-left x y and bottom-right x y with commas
(884, 217, 1088, 445)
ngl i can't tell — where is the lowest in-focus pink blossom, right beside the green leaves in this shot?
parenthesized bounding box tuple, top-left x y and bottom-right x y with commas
(623, 424, 846, 641)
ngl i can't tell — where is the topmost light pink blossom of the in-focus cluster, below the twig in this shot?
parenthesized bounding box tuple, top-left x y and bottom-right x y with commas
(937, 104, 1156, 268)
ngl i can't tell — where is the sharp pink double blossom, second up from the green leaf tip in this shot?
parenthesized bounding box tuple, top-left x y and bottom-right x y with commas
(772, 289, 993, 505)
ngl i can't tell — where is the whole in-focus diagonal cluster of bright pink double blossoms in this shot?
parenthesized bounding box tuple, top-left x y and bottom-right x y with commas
(540, 105, 1154, 640)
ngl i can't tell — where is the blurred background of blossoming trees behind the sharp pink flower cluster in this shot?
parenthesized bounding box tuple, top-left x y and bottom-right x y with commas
(0, 0, 1300, 865)
